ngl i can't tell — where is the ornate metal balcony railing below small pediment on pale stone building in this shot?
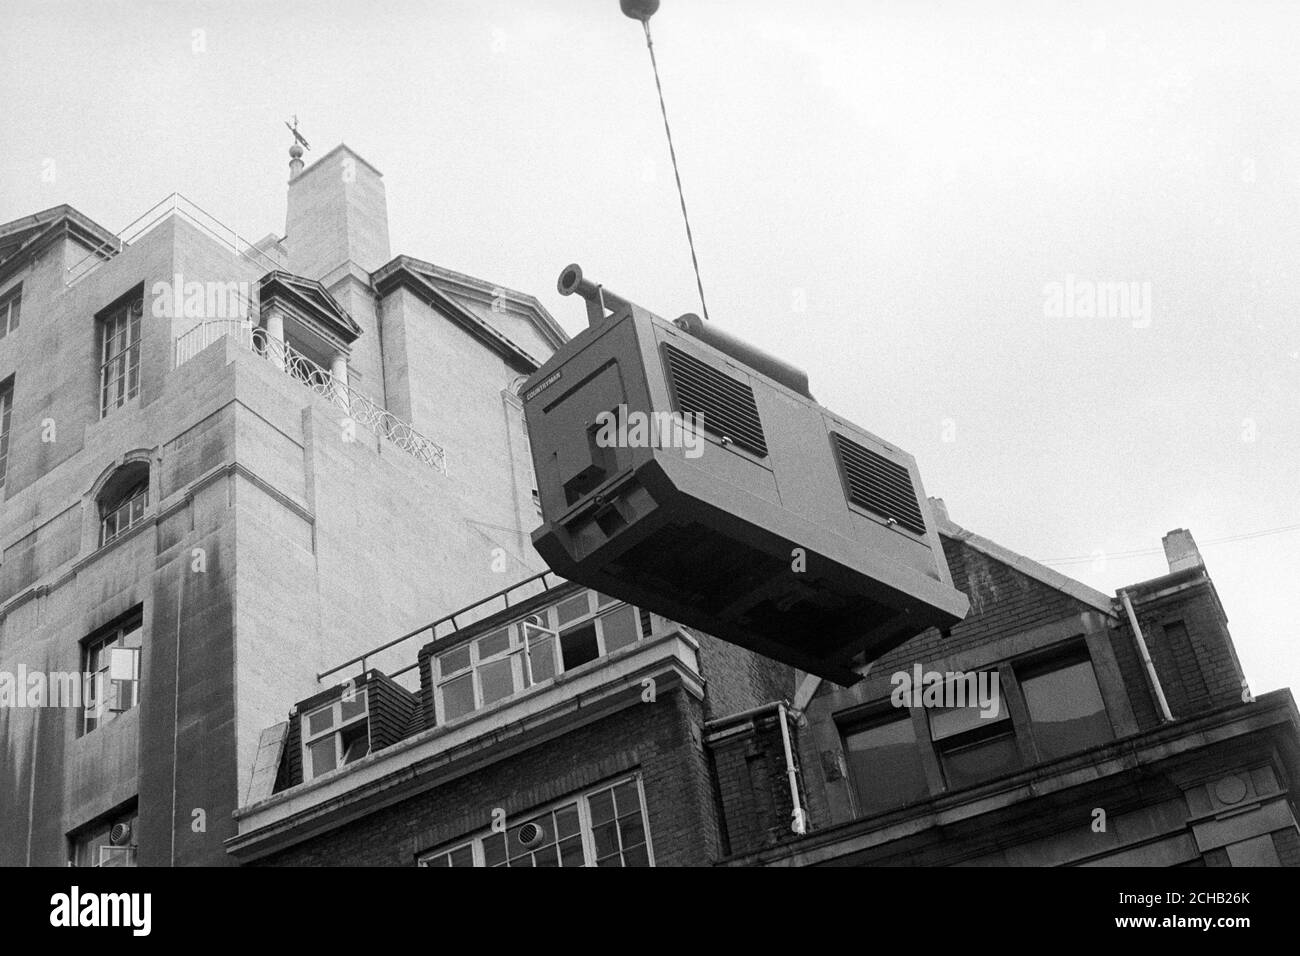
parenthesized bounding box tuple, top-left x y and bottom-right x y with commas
(176, 319, 447, 475)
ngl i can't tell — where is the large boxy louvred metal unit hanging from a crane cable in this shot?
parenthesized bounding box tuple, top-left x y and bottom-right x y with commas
(523, 265, 967, 684)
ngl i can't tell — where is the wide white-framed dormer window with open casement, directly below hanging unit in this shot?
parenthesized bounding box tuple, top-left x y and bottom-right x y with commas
(430, 591, 642, 724)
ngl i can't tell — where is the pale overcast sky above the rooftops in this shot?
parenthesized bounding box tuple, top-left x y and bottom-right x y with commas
(0, 0, 1300, 692)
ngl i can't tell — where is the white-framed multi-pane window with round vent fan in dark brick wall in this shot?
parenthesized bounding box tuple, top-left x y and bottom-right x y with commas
(420, 777, 654, 866)
